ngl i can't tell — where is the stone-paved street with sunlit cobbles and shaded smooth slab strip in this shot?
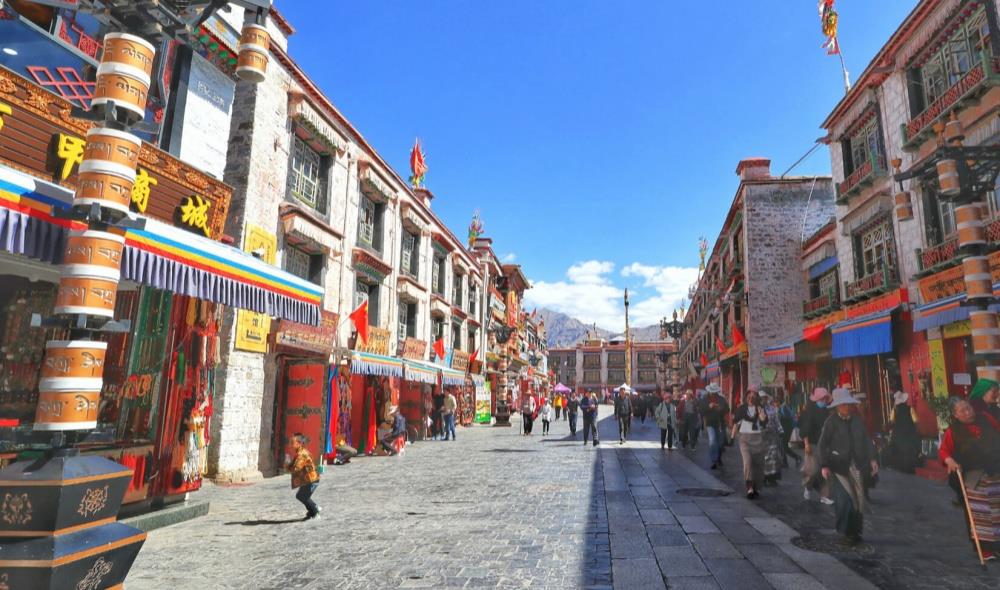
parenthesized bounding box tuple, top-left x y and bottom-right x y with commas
(128, 408, 872, 590)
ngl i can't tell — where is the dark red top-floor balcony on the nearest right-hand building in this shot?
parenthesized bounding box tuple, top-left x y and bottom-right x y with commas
(902, 52, 1000, 151)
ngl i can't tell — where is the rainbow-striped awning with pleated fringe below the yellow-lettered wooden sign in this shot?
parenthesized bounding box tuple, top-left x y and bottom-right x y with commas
(0, 165, 323, 325)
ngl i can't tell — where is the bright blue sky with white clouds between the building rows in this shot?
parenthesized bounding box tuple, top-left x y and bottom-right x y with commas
(277, 0, 916, 329)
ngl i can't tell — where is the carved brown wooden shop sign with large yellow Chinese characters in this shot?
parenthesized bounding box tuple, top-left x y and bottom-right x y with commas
(0, 68, 232, 239)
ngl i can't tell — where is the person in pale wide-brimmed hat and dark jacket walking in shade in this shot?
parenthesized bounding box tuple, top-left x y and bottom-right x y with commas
(819, 388, 878, 546)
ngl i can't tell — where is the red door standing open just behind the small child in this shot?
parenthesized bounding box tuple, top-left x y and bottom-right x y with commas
(280, 361, 326, 461)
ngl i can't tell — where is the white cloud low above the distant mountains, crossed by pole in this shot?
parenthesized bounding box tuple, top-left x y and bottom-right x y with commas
(524, 260, 698, 332)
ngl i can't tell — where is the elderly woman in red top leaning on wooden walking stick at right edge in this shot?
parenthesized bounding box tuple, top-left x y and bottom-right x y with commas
(938, 397, 1000, 561)
